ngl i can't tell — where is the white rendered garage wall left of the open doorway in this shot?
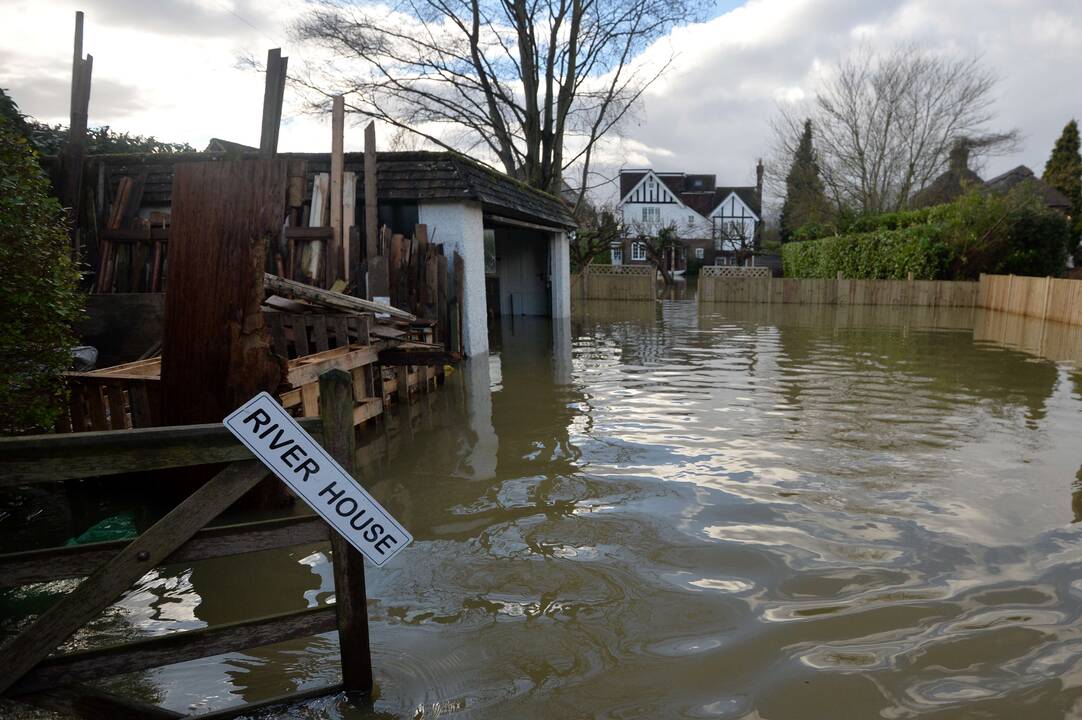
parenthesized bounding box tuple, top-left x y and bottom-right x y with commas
(418, 202, 488, 356)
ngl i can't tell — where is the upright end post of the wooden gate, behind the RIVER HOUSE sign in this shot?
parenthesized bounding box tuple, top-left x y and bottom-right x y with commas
(319, 370, 372, 694)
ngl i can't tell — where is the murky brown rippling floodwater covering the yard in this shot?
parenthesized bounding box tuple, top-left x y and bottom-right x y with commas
(5, 299, 1082, 719)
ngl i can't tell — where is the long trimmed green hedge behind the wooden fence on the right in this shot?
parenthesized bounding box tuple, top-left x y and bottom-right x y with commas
(781, 187, 1071, 279)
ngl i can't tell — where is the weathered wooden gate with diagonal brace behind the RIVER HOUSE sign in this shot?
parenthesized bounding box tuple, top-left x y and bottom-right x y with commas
(0, 370, 372, 718)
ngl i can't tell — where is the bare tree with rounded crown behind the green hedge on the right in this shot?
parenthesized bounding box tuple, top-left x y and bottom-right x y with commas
(771, 47, 1017, 213)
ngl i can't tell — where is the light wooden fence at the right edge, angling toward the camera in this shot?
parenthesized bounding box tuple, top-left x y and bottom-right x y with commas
(977, 275, 1082, 325)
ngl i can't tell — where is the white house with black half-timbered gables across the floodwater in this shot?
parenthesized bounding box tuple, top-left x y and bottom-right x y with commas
(611, 160, 763, 272)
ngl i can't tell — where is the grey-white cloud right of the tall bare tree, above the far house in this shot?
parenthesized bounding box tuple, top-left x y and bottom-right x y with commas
(625, 0, 1082, 204)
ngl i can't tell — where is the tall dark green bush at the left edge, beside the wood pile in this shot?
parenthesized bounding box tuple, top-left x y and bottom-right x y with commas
(0, 109, 82, 433)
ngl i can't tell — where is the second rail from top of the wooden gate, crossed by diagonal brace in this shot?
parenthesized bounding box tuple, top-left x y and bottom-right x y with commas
(0, 515, 328, 588)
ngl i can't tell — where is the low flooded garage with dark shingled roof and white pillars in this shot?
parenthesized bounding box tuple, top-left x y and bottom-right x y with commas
(75, 148, 575, 355)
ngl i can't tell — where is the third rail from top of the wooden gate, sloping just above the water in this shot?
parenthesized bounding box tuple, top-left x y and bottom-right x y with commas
(12, 605, 335, 694)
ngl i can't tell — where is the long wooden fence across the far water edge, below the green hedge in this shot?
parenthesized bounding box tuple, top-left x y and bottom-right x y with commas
(699, 269, 978, 307)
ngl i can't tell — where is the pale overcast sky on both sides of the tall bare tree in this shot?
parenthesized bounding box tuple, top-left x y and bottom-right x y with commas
(0, 0, 1082, 204)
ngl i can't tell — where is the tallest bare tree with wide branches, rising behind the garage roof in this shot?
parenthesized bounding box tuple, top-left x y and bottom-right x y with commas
(294, 0, 703, 204)
